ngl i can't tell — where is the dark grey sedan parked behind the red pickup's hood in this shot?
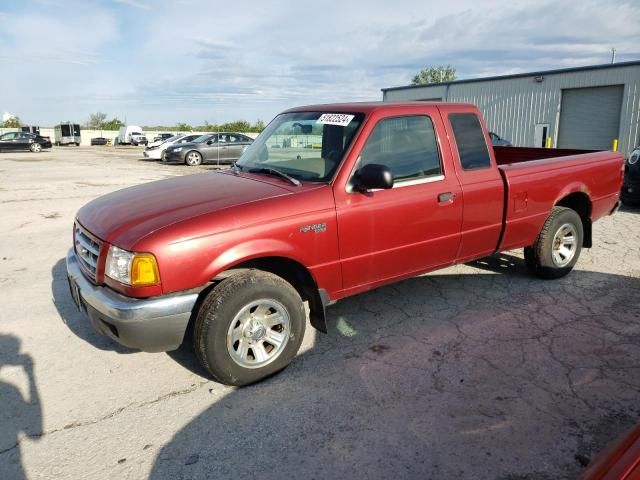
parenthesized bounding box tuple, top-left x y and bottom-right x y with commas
(163, 132, 253, 166)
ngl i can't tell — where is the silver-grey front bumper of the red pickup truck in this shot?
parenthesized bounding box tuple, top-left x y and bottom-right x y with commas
(67, 249, 198, 352)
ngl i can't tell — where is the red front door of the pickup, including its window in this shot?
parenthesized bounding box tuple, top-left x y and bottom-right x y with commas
(335, 112, 462, 294)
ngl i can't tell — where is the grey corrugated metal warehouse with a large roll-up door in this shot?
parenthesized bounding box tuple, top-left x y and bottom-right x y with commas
(382, 61, 640, 157)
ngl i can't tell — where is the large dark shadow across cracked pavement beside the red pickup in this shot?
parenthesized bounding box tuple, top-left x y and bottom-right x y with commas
(150, 254, 640, 479)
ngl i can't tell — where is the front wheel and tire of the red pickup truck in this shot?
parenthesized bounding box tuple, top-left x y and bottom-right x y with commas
(193, 270, 306, 386)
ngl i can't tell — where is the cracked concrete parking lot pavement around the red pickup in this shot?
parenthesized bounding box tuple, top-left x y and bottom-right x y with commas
(0, 147, 640, 480)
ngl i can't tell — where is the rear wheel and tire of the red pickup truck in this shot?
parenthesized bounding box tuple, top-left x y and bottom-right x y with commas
(524, 207, 584, 279)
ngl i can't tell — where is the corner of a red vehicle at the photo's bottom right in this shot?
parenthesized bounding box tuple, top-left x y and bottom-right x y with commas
(578, 425, 640, 480)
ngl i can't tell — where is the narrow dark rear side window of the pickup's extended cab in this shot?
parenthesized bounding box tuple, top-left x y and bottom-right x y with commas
(449, 113, 491, 170)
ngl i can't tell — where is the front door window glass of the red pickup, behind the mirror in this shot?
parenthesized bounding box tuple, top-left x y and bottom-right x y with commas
(358, 115, 442, 183)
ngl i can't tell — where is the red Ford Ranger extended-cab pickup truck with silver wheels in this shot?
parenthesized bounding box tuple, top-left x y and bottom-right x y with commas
(67, 102, 623, 385)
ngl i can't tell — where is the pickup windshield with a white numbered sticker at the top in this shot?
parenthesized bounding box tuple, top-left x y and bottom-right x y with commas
(236, 112, 364, 182)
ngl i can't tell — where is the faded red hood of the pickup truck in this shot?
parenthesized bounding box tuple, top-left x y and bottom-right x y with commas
(77, 172, 291, 250)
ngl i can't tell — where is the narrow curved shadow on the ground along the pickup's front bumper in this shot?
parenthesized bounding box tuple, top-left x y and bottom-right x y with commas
(51, 258, 137, 354)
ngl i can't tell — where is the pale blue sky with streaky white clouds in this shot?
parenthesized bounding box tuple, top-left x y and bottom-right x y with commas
(0, 0, 640, 126)
